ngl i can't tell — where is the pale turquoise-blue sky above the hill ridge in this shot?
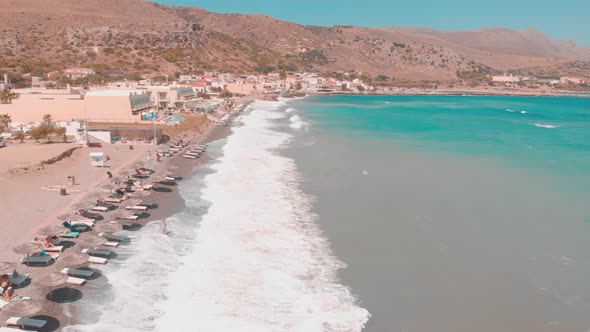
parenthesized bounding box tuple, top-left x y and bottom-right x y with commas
(156, 0, 590, 46)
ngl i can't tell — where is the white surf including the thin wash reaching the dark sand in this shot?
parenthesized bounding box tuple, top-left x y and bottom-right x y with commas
(65, 101, 370, 332)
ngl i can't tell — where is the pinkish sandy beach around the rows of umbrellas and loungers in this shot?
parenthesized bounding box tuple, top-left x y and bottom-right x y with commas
(0, 100, 242, 331)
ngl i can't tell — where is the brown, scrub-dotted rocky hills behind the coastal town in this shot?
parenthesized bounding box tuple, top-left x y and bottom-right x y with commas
(0, 0, 590, 81)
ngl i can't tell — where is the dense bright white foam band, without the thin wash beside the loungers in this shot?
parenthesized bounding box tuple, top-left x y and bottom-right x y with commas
(156, 102, 369, 332)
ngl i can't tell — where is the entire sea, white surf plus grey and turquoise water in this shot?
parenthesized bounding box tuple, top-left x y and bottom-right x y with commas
(66, 96, 590, 332)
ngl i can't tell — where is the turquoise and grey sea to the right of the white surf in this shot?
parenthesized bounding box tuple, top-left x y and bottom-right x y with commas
(290, 96, 590, 331)
